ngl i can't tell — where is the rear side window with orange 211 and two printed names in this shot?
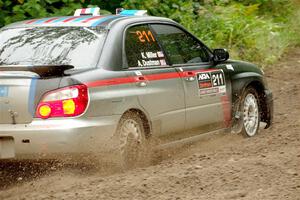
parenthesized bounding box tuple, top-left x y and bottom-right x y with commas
(125, 25, 166, 67)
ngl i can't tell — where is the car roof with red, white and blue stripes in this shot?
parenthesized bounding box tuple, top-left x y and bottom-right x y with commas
(4, 15, 173, 29)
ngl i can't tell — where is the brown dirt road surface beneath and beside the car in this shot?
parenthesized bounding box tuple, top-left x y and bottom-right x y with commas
(0, 49, 300, 200)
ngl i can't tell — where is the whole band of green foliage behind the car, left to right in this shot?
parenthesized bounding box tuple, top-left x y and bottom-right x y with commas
(0, 0, 300, 64)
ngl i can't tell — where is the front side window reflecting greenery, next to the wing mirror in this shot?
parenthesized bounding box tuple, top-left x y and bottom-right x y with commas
(151, 24, 210, 64)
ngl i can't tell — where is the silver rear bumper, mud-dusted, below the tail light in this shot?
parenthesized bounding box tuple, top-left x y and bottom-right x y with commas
(0, 115, 121, 159)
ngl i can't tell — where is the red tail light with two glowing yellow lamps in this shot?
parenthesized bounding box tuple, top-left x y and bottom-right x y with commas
(36, 85, 89, 119)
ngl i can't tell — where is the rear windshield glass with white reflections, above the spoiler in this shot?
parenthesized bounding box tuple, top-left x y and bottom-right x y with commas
(0, 27, 106, 69)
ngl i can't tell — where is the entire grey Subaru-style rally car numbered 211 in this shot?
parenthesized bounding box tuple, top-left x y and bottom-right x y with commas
(0, 8, 273, 166)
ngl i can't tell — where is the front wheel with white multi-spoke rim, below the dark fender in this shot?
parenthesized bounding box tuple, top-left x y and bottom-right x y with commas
(240, 87, 260, 137)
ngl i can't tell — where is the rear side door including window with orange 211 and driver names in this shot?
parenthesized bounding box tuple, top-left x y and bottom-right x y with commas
(125, 24, 185, 136)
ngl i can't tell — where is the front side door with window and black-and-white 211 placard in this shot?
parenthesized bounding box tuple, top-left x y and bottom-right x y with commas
(151, 24, 230, 132)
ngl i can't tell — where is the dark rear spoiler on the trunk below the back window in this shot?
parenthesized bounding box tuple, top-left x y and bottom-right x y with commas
(0, 65, 74, 78)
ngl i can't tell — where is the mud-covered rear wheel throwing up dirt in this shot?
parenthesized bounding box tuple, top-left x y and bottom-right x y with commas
(117, 112, 150, 169)
